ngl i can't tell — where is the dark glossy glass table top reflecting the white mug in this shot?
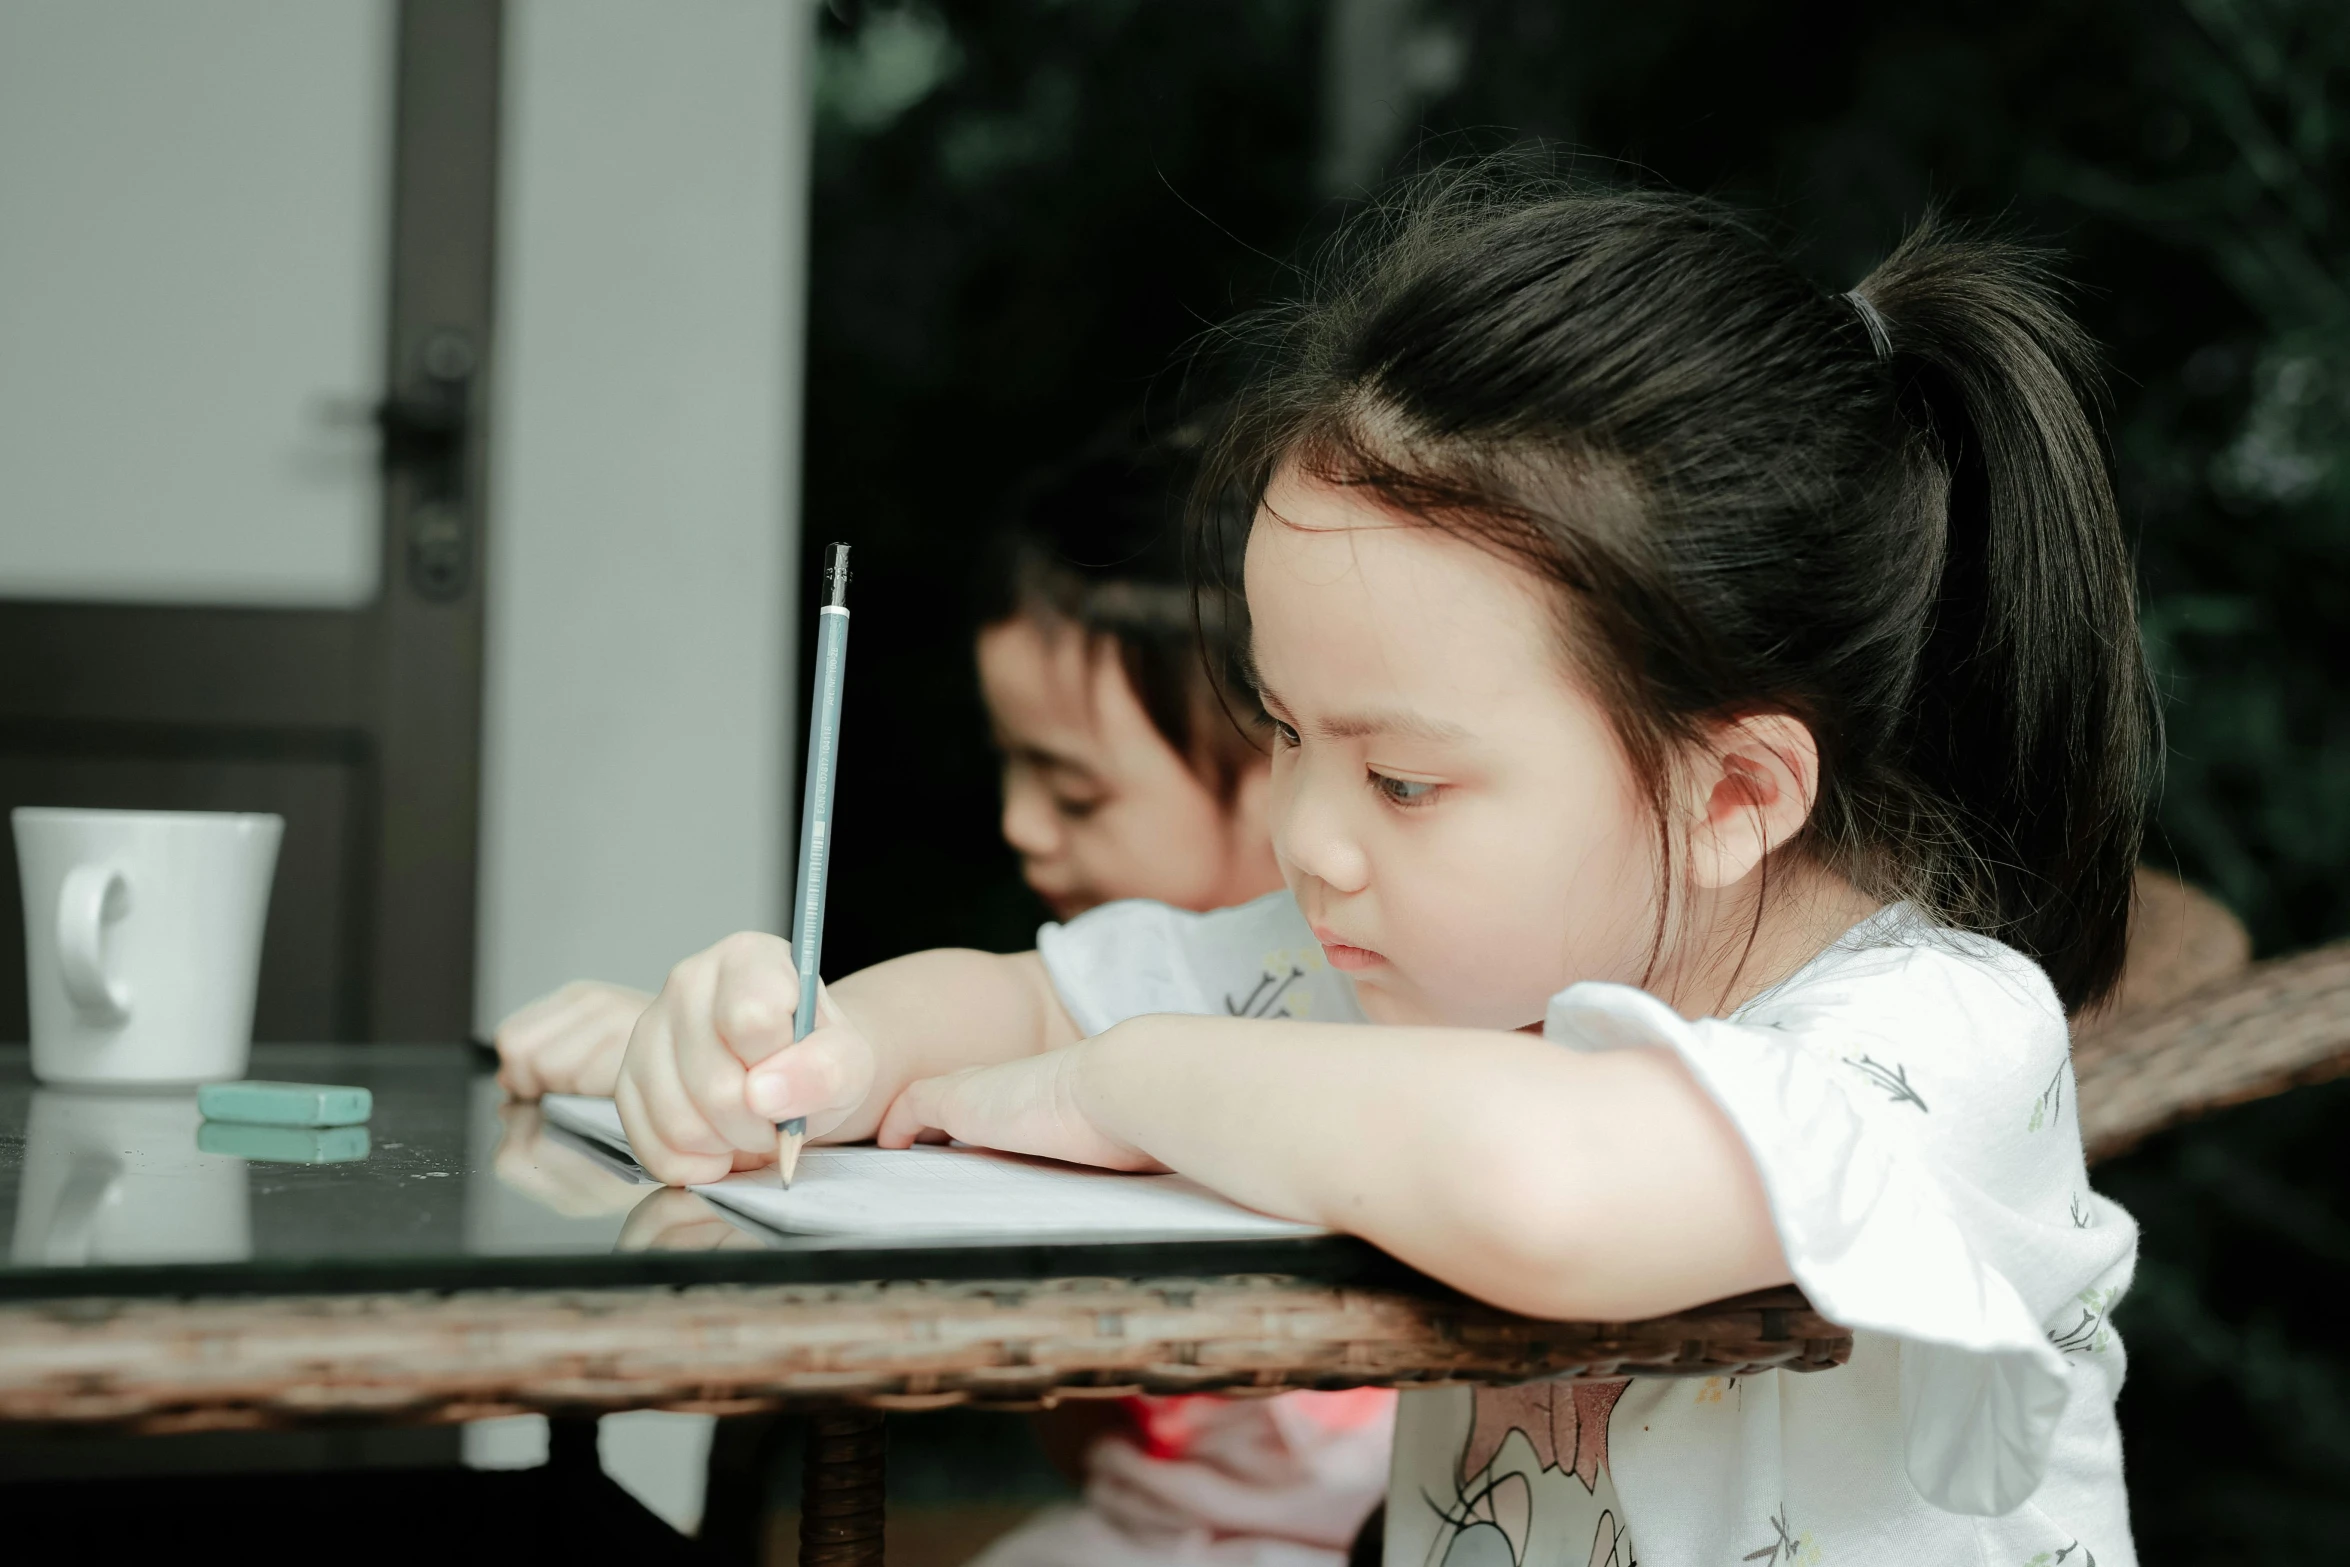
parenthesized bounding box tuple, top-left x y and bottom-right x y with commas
(0, 1045, 1391, 1302)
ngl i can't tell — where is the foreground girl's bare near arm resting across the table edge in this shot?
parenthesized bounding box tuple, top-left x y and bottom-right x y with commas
(1079, 1017, 1786, 1318)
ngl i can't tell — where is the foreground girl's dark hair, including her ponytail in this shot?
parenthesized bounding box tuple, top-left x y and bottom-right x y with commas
(1203, 164, 2155, 1010)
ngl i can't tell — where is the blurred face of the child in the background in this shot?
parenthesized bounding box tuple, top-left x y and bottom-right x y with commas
(980, 616, 1281, 919)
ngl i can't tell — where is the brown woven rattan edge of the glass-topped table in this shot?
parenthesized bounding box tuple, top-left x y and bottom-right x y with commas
(0, 1278, 1852, 1431)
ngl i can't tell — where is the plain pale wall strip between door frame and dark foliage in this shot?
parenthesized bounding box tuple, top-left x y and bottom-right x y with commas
(475, 0, 813, 1036)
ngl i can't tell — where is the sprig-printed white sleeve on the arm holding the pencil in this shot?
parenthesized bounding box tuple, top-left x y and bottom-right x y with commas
(1036, 893, 1363, 1036)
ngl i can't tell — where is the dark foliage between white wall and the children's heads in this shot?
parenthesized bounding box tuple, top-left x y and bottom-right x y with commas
(806, 0, 1318, 973)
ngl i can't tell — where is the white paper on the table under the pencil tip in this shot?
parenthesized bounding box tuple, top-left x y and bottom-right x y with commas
(543, 1095, 1328, 1245)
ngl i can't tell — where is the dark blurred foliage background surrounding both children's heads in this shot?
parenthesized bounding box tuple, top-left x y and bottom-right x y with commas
(808, 0, 2350, 1562)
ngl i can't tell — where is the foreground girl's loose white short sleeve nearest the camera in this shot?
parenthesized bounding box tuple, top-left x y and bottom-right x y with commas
(1544, 930, 2136, 1515)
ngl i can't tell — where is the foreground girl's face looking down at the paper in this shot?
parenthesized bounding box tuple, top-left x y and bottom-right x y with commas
(1248, 475, 1657, 1029)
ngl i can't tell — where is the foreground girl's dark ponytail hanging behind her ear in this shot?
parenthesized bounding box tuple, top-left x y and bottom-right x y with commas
(1854, 221, 2157, 1010)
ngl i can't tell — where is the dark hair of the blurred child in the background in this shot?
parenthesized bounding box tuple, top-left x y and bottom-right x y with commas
(978, 413, 1262, 803)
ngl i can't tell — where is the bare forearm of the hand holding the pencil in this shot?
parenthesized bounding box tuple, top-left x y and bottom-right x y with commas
(827, 947, 1079, 1142)
